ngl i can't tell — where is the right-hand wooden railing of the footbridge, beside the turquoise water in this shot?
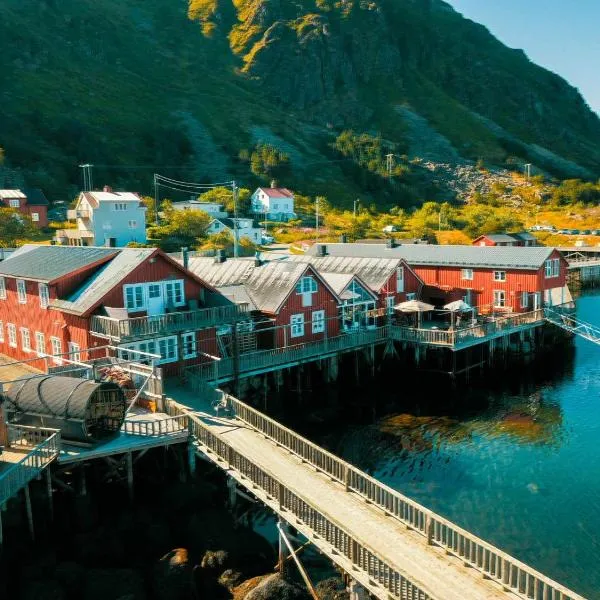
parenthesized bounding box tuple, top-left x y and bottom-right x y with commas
(221, 396, 584, 600)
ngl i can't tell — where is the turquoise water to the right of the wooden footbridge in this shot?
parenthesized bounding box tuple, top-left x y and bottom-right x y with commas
(337, 296, 600, 599)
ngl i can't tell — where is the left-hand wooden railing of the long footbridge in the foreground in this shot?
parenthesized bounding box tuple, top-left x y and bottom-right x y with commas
(189, 415, 434, 600)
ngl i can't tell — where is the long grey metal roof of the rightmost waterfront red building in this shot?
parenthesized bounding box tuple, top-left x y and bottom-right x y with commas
(307, 244, 555, 270)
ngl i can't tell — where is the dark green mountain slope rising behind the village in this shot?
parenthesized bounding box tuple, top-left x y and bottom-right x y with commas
(0, 0, 600, 204)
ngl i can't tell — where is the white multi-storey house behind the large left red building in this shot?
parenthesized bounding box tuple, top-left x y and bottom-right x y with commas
(55, 186, 146, 247)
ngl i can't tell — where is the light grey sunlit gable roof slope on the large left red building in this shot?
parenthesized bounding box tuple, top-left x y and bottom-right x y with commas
(51, 248, 156, 314)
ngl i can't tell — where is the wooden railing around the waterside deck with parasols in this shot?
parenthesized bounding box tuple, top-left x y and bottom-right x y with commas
(391, 309, 545, 348)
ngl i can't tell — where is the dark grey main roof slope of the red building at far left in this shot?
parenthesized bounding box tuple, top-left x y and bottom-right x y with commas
(0, 244, 121, 281)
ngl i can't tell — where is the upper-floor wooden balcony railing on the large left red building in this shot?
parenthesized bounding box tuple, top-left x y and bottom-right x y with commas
(90, 304, 249, 342)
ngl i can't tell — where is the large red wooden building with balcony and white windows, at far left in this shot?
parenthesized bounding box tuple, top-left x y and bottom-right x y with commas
(0, 246, 239, 368)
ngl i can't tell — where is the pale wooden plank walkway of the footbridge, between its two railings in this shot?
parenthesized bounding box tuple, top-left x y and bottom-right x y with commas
(196, 413, 515, 600)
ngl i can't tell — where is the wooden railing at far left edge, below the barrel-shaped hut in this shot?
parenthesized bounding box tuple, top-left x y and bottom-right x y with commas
(0, 425, 60, 506)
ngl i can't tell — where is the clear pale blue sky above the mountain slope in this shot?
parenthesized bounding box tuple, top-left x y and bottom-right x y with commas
(446, 0, 600, 114)
